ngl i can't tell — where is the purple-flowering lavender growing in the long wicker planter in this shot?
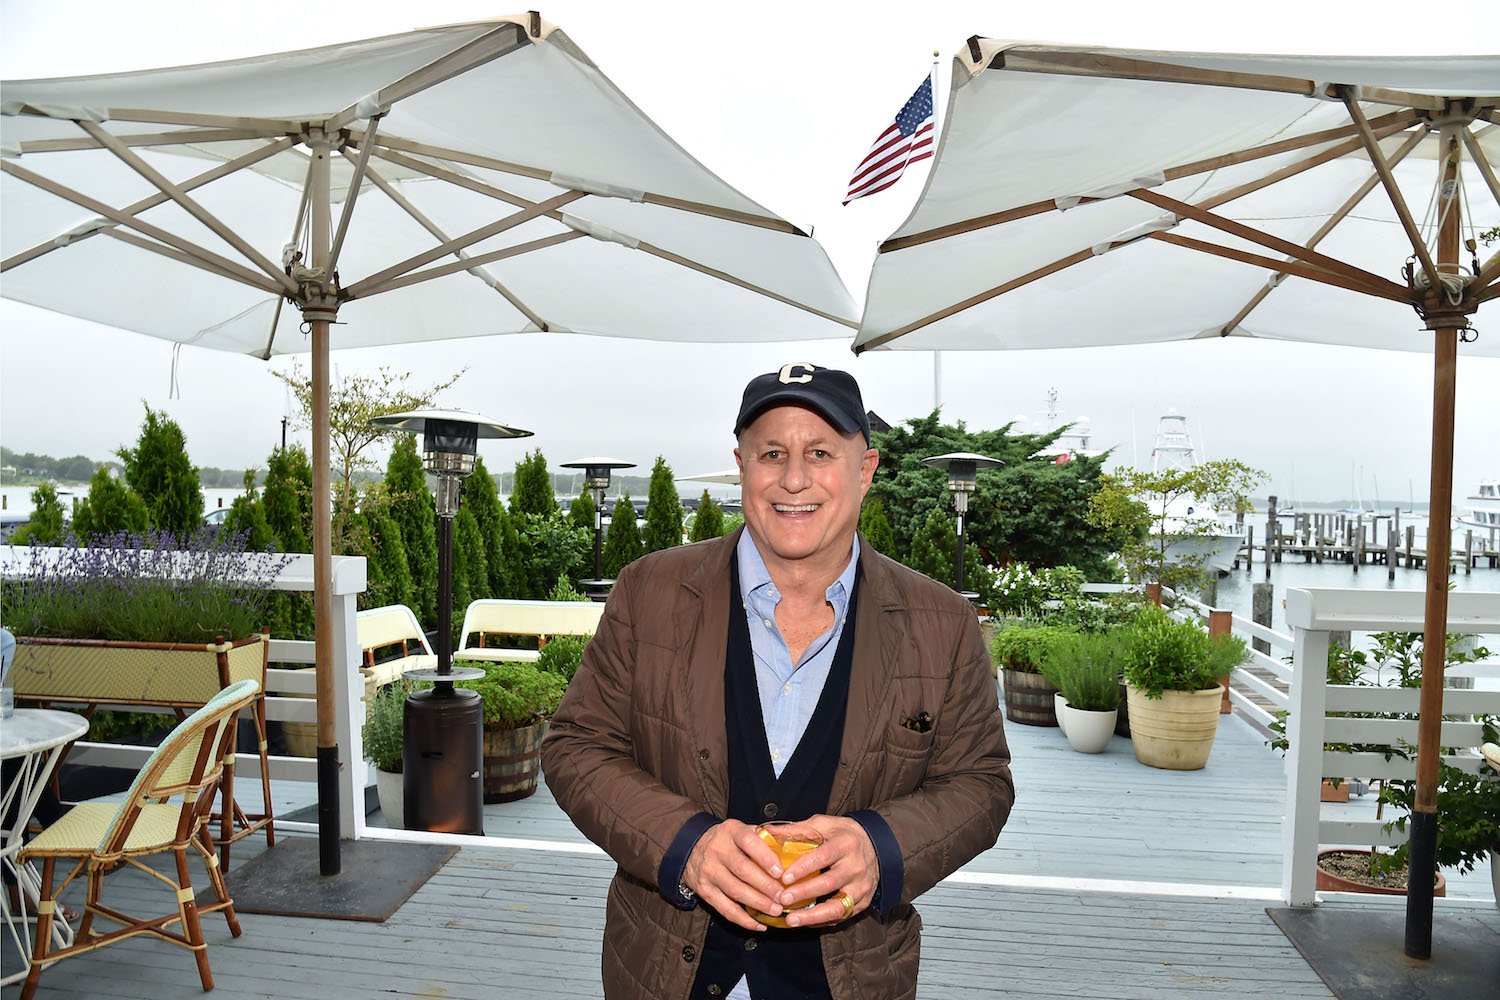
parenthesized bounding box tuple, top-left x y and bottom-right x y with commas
(0, 532, 291, 642)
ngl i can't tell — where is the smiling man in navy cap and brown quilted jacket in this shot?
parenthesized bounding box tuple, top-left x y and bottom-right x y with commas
(542, 364, 1014, 1000)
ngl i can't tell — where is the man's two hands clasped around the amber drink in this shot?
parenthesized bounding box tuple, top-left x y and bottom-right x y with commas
(683, 816, 881, 931)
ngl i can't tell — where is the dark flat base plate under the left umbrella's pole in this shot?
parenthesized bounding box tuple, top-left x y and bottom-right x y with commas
(227, 837, 458, 924)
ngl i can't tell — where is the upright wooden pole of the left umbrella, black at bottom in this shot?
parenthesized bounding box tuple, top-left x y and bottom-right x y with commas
(303, 141, 341, 876)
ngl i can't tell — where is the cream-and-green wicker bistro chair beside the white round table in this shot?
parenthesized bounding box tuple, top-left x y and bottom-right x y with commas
(21, 679, 260, 1000)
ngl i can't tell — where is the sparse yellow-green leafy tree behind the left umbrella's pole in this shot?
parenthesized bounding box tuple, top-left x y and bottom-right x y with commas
(272, 363, 468, 510)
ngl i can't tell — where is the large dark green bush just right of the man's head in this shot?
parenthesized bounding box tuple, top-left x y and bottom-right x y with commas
(866, 411, 1124, 580)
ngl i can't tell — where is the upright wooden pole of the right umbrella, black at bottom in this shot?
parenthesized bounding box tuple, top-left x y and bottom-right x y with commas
(1406, 136, 1463, 958)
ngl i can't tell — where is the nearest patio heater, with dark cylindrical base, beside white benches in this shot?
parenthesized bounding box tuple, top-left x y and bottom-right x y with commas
(371, 409, 531, 835)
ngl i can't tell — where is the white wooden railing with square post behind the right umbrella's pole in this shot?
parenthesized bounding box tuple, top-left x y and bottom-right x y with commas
(1281, 589, 1500, 906)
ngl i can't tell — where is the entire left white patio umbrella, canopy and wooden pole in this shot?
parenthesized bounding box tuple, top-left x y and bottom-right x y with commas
(0, 13, 855, 874)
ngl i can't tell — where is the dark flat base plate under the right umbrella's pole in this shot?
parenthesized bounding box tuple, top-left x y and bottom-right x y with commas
(1266, 907, 1500, 1000)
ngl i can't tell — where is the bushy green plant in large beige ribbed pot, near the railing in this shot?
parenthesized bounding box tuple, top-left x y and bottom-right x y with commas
(1125, 607, 1245, 771)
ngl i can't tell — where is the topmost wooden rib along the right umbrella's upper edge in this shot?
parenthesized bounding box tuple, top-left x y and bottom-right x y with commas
(989, 48, 1443, 111)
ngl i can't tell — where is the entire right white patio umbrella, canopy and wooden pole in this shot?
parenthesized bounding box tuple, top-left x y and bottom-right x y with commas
(855, 37, 1500, 957)
